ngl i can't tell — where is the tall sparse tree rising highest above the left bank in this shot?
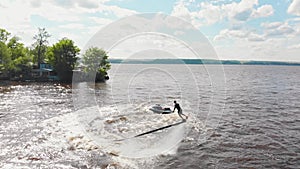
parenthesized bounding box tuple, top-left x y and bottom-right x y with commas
(33, 28, 51, 68)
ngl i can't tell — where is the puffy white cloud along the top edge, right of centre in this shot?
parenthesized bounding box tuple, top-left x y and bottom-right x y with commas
(186, 0, 274, 26)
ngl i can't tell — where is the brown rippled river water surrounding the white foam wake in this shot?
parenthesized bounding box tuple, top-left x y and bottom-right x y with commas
(0, 65, 300, 168)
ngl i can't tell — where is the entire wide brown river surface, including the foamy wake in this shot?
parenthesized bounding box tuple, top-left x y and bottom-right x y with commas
(0, 64, 300, 169)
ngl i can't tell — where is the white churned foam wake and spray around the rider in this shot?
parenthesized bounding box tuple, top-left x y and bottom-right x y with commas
(39, 101, 196, 168)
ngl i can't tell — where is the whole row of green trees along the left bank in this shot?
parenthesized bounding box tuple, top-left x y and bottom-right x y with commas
(0, 28, 110, 82)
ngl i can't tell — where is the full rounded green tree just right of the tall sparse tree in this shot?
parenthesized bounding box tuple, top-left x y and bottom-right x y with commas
(47, 38, 80, 82)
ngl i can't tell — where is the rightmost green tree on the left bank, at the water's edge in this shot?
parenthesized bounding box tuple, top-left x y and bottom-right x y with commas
(83, 47, 110, 82)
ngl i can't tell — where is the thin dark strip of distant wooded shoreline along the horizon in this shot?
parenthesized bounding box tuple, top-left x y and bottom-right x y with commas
(109, 59, 300, 66)
